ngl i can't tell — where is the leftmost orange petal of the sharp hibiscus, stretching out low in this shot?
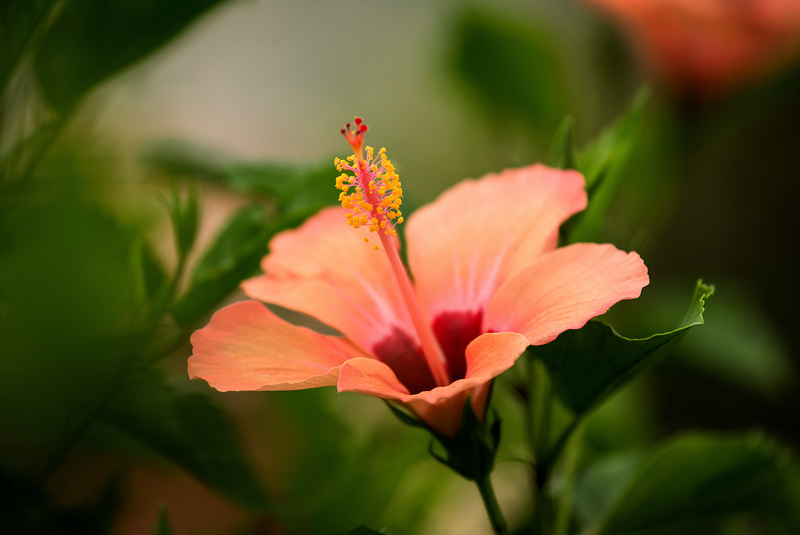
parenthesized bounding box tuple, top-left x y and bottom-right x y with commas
(189, 301, 365, 392)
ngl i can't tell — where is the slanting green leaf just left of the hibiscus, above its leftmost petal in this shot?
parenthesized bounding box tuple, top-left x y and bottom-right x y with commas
(172, 204, 272, 327)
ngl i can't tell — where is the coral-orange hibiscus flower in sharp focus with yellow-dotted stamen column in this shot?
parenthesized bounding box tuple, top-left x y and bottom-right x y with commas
(189, 118, 649, 437)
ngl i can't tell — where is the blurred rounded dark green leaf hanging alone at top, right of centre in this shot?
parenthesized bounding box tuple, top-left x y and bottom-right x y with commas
(452, 8, 568, 136)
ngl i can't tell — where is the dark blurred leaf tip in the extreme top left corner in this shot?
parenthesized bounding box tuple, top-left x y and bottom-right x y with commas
(0, 0, 58, 94)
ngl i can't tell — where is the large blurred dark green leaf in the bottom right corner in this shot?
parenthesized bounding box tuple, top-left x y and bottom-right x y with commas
(592, 433, 800, 535)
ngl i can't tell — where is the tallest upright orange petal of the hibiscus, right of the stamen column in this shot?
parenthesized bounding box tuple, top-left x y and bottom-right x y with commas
(406, 165, 586, 317)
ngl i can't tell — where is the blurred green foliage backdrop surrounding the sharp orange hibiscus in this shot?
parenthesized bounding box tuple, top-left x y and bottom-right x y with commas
(0, 0, 800, 534)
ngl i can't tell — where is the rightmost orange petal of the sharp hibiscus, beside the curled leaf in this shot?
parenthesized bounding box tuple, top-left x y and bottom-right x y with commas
(484, 243, 650, 345)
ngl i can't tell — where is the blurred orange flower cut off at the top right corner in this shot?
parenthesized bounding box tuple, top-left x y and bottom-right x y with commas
(589, 0, 800, 96)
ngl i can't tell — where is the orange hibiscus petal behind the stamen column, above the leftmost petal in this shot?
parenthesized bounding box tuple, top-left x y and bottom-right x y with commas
(242, 207, 415, 353)
